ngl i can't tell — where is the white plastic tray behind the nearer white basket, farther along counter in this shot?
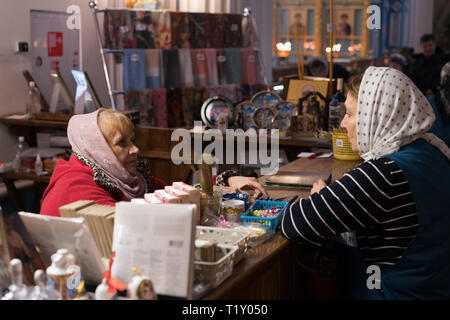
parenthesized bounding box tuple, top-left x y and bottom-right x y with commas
(195, 226, 251, 264)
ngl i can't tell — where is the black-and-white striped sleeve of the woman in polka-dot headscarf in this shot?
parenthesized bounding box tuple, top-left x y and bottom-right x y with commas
(281, 158, 418, 266)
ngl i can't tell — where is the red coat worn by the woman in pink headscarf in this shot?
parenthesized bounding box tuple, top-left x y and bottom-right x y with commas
(40, 155, 165, 217)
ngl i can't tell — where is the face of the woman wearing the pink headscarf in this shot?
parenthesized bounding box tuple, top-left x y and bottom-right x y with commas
(106, 131, 139, 175)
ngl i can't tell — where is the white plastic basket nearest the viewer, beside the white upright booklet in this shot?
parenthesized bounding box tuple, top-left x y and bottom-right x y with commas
(194, 245, 239, 288)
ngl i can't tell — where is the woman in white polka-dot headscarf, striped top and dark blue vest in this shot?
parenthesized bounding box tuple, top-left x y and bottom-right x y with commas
(281, 67, 450, 299)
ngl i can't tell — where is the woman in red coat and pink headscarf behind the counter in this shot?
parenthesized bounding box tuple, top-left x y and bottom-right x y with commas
(41, 109, 267, 216)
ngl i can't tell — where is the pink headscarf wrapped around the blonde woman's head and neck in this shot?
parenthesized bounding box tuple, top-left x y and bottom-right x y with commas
(67, 109, 147, 200)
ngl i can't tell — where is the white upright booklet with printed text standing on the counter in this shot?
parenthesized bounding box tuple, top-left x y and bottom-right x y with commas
(111, 202, 196, 299)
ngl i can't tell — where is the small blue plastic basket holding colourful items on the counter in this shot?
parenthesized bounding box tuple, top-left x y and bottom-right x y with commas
(241, 200, 288, 231)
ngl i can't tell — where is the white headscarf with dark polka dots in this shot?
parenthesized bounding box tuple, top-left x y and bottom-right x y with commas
(356, 67, 450, 161)
